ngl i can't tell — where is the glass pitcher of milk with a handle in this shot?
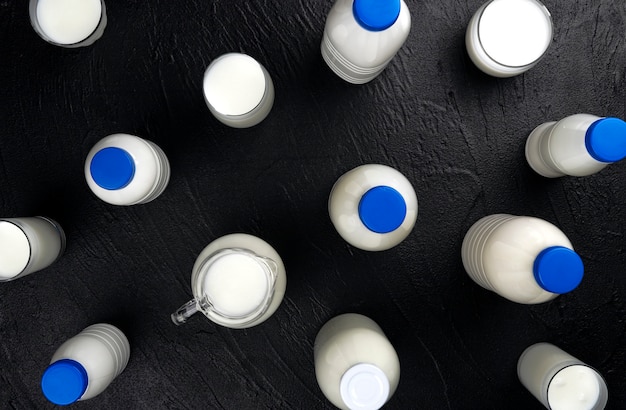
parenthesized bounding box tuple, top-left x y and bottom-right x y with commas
(171, 234, 287, 329)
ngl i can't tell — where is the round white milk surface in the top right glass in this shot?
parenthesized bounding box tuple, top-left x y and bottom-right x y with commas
(478, 0, 552, 67)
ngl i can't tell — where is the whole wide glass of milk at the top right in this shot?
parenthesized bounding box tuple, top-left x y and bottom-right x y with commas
(465, 0, 552, 77)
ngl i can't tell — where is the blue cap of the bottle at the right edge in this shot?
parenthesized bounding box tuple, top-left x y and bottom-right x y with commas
(585, 118, 626, 162)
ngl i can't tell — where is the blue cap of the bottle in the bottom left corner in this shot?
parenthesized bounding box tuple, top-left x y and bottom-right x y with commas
(41, 359, 88, 406)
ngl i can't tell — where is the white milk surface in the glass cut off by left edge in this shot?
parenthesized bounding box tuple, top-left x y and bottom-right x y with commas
(0, 221, 30, 280)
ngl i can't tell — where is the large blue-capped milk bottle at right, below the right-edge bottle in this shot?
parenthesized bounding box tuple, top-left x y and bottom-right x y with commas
(461, 214, 584, 304)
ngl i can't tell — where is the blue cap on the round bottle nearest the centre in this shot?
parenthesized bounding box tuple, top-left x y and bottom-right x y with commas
(359, 185, 406, 233)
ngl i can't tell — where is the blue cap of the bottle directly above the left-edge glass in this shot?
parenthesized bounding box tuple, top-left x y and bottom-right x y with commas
(89, 147, 135, 190)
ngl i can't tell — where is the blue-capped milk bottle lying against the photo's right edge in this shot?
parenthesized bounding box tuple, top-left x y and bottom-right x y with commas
(526, 114, 626, 178)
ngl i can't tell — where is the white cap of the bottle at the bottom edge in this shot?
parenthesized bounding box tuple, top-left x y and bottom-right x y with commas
(339, 363, 389, 410)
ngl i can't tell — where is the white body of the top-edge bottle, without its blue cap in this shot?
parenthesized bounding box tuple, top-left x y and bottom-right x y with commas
(321, 0, 411, 84)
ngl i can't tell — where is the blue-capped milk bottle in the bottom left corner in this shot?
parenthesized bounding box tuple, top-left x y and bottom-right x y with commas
(41, 323, 130, 405)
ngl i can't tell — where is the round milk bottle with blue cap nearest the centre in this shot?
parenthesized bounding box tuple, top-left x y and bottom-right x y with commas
(328, 164, 417, 251)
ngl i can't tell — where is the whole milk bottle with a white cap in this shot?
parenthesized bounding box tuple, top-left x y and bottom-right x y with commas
(314, 313, 400, 410)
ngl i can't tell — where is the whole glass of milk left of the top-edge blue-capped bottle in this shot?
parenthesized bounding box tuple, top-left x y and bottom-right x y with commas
(203, 53, 274, 128)
